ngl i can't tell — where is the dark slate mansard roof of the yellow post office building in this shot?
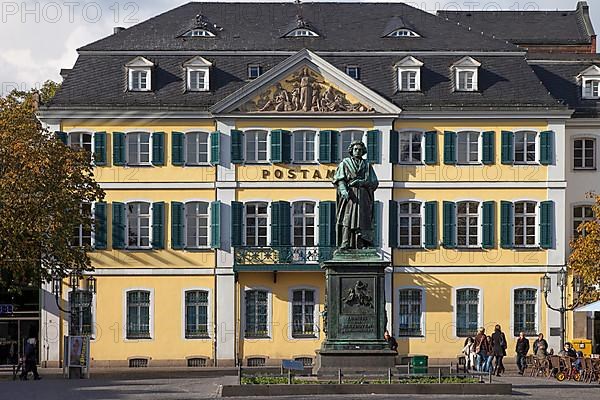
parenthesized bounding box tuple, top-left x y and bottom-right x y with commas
(49, 2, 565, 111)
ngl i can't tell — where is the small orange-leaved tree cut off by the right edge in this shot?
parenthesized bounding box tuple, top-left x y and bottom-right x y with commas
(569, 193, 600, 304)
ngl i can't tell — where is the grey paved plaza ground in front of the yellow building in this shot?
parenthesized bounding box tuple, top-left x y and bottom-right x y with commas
(0, 375, 600, 400)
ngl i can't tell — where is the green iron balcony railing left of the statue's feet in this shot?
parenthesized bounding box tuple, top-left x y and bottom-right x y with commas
(233, 246, 335, 266)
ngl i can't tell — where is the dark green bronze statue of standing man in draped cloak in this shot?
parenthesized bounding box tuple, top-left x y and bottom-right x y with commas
(333, 140, 379, 249)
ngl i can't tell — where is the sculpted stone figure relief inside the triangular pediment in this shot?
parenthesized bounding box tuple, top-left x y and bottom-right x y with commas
(241, 67, 374, 113)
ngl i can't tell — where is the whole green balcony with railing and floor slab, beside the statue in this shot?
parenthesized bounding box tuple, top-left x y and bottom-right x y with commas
(233, 246, 335, 271)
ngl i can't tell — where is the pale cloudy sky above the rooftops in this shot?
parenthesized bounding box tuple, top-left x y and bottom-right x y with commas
(0, 0, 600, 95)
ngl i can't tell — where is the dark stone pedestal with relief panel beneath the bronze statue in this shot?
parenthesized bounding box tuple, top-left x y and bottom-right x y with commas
(314, 249, 396, 376)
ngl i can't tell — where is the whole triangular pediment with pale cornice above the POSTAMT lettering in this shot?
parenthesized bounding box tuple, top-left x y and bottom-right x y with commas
(211, 50, 401, 115)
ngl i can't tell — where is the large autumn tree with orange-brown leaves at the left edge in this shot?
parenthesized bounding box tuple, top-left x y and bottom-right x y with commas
(0, 81, 104, 290)
